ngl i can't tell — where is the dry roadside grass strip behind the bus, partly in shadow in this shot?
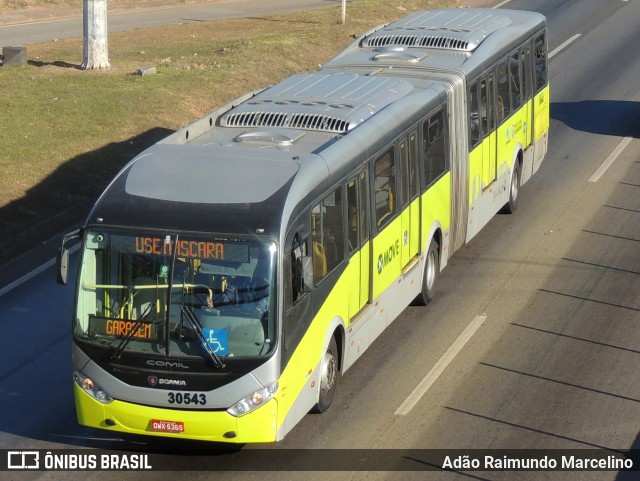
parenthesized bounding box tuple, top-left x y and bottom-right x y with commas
(0, 0, 458, 264)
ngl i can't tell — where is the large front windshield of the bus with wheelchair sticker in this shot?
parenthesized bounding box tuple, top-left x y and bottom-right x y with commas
(73, 229, 276, 360)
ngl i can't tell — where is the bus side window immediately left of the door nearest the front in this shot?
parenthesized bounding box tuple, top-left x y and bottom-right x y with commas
(311, 187, 345, 284)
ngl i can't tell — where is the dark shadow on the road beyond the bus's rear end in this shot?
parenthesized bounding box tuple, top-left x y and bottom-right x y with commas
(551, 100, 640, 138)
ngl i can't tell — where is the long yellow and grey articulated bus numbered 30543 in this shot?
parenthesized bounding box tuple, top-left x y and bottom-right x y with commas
(58, 9, 549, 443)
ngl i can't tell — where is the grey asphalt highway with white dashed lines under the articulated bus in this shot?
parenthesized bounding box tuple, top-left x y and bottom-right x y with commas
(0, 0, 640, 481)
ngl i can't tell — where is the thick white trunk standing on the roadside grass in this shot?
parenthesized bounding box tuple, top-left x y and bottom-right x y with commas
(82, 0, 111, 70)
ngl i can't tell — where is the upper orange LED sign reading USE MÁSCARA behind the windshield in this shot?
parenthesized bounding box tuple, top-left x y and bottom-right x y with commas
(111, 235, 249, 262)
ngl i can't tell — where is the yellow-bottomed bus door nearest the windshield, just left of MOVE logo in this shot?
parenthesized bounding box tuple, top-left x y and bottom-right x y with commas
(347, 170, 371, 318)
